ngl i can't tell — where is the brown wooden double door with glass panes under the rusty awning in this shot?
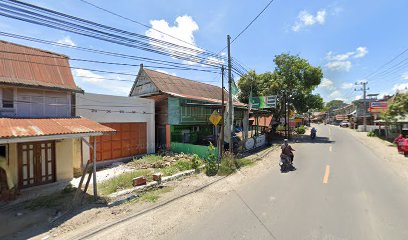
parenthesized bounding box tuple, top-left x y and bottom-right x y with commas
(18, 141, 56, 188)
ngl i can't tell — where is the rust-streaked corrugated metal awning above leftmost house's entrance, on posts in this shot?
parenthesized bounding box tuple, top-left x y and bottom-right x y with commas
(0, 117, 115, 143)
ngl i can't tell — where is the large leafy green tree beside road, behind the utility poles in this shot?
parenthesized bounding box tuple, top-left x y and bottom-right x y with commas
(238, 53, 323, 118)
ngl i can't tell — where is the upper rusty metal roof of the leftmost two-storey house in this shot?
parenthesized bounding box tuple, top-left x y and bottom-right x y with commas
(0, 40, 81, 91)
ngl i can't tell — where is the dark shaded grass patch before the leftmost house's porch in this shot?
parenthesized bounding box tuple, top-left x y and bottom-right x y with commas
(25, 184, 76, 211)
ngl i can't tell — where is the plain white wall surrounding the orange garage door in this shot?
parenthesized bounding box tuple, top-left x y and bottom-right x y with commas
(75, 93, 155, 162)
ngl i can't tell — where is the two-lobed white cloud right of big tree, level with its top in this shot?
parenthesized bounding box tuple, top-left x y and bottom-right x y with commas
(325, 47, 368, 72)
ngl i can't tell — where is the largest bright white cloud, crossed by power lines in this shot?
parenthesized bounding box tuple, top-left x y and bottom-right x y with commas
(145, 15, 203, 65)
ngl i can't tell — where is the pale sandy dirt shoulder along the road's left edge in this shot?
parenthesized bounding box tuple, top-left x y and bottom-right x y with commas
(2, 146, 279, 239)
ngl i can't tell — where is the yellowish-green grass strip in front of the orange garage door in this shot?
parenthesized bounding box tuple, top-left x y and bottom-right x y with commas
(99, 169, 153, 195)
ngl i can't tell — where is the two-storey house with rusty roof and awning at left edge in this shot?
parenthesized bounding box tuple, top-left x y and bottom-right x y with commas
(0, 41, 115, 200)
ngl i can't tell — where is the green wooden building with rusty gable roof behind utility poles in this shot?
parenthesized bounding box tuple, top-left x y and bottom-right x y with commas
(130, 65, 248, 157)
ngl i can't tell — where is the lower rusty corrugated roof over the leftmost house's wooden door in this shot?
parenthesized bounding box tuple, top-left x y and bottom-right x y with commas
(0, 118, 115, 138)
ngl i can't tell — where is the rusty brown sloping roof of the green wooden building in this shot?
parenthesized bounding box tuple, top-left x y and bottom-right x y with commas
(143, 68, 246, 106)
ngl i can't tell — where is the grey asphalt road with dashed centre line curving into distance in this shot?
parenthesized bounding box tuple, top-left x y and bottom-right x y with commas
(176, 125, 408, 240)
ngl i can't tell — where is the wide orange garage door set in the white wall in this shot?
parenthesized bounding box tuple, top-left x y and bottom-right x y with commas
(91, 123, 147, 161)
